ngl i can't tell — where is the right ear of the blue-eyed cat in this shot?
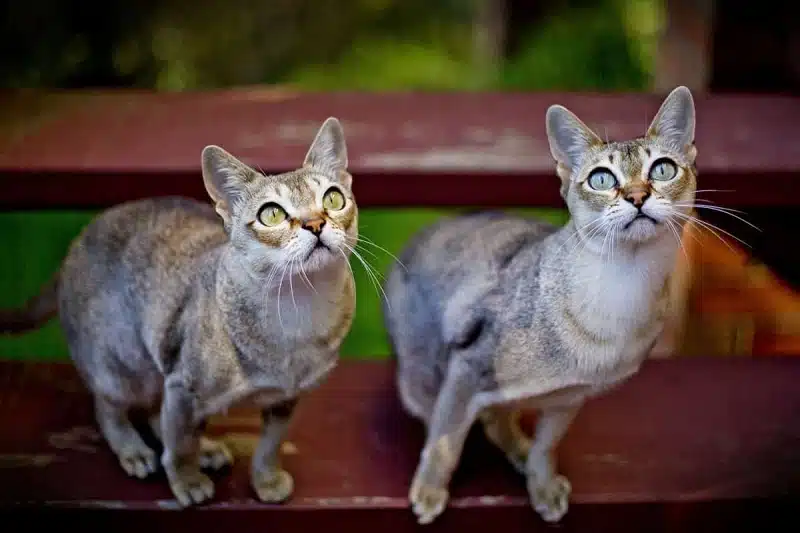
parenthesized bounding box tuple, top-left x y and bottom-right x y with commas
(647, 86, 695, 160)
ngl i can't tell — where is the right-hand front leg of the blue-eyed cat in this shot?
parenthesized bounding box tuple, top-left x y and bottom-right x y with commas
(525, 405, 580, 522)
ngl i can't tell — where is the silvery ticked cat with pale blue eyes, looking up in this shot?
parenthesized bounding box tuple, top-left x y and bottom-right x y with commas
(383, 87, 696, 524)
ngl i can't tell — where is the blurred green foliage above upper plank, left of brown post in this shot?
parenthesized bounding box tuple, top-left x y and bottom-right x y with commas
(0, 0, 663, 91)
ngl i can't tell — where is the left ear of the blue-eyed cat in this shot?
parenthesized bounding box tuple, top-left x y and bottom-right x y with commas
(545, 105, 603, 171)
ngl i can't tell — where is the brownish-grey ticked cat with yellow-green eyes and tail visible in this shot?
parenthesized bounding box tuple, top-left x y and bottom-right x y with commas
(0, 117, 358, 506)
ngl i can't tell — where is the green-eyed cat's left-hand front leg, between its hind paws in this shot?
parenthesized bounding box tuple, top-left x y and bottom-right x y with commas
(161, 378, 214, 507)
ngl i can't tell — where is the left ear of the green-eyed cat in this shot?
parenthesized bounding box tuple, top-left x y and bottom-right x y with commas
(202, 145, 257, 226)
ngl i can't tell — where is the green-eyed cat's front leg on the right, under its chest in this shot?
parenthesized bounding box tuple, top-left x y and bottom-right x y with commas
(250, 400, 296, 503)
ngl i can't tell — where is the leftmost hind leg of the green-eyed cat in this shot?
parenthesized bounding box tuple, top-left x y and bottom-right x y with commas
(94, 394, 158, 478)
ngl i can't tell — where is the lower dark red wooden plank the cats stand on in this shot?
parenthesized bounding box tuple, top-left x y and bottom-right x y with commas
(0, 358, 800, 532)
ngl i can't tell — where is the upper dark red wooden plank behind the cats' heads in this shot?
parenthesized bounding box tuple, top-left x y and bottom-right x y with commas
(0, 89, 800, 209)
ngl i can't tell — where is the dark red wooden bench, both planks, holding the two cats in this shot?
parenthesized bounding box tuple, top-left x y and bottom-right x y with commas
(0, 89, 800, 532)
